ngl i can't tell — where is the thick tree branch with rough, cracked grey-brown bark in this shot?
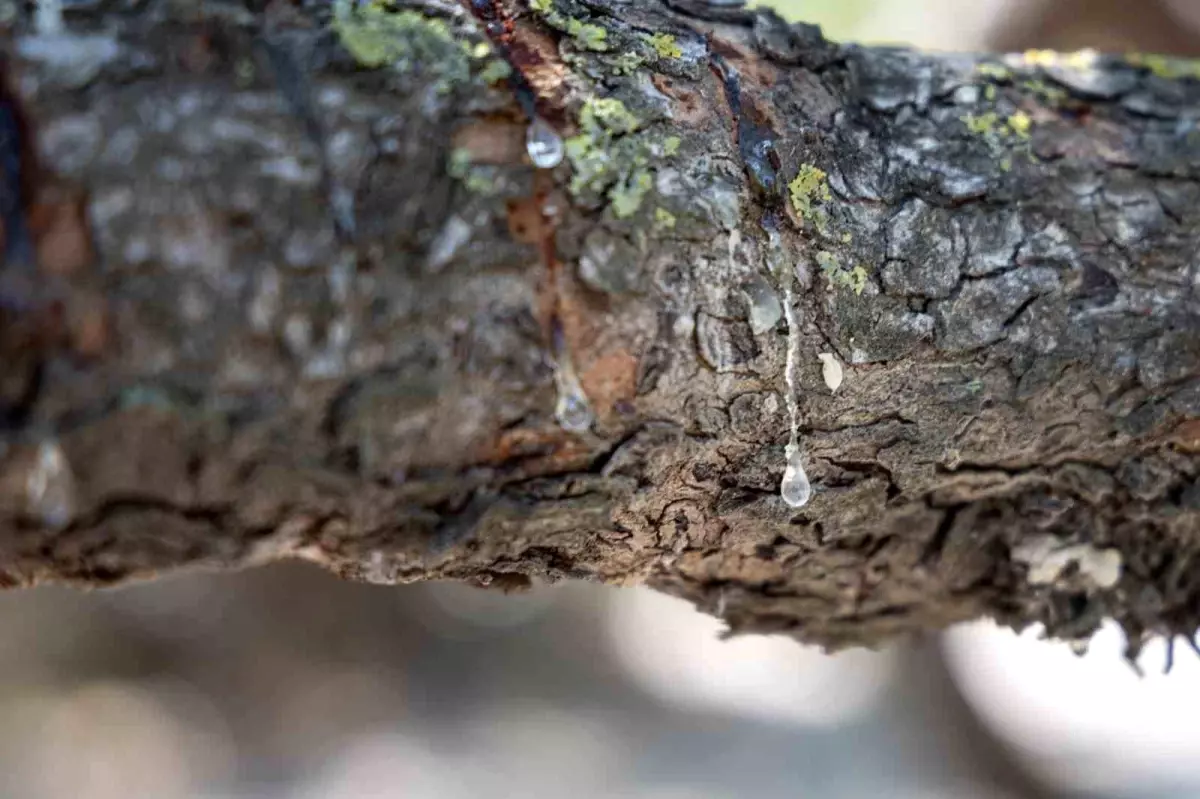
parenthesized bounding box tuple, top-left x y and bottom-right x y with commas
(0, 0, 1200, 653)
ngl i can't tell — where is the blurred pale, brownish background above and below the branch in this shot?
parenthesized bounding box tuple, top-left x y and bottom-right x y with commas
(7, 0, 1200, 799)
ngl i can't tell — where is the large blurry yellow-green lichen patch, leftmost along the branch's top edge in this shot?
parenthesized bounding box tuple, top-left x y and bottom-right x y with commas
(334, 0, 472, 91)
